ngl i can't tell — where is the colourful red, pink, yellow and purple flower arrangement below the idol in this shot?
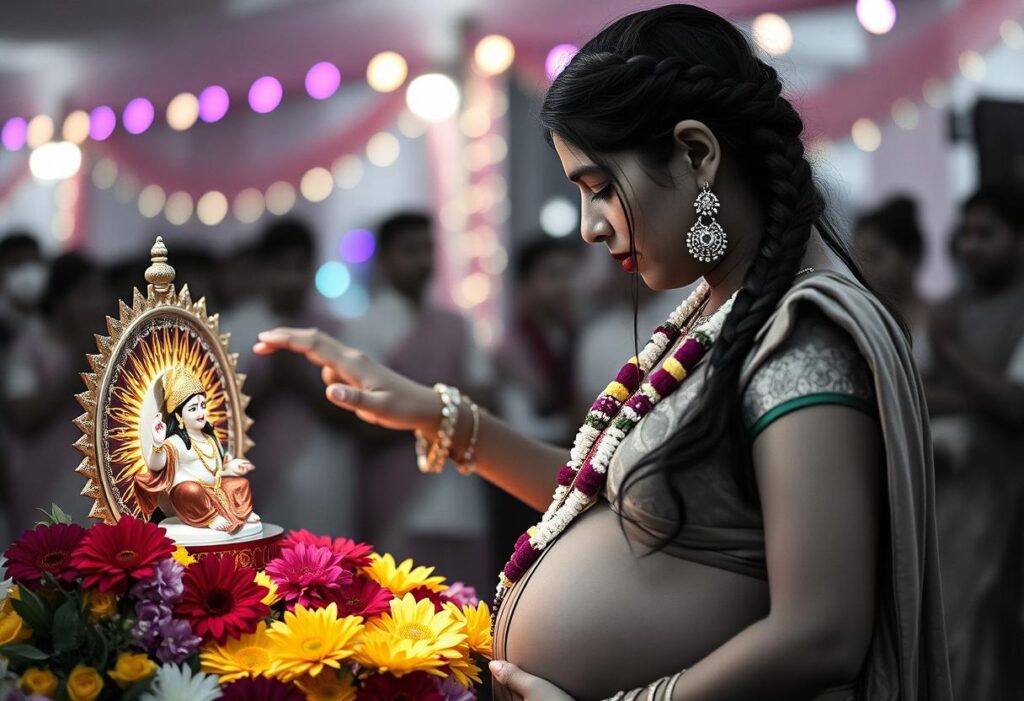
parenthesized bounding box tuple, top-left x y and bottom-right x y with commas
(0, 508, 492, 701)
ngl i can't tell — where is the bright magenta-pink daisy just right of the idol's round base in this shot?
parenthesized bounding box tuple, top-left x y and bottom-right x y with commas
(266, 542, 352, 609)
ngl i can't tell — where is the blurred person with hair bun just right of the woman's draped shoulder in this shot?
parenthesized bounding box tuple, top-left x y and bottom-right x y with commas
(853, 194, 929, 371)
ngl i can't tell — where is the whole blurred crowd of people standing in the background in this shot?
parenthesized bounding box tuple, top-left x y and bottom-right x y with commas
(0, 187, 1024, 698)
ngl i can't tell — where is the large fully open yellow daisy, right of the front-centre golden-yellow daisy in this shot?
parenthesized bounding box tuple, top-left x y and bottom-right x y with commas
(355, 594, 466, 676)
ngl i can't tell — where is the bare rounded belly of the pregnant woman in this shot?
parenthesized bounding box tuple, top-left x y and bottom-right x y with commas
(495, 501, 768, 701)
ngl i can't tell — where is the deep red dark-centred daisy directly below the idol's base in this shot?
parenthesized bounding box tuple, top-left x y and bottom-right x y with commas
(174, 556, 270, 645)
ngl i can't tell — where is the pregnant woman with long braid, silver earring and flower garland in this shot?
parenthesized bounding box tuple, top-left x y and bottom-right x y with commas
(256, 5, 950, 701)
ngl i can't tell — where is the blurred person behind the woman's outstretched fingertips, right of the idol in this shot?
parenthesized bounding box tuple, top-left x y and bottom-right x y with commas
(220, 219, 355, 535)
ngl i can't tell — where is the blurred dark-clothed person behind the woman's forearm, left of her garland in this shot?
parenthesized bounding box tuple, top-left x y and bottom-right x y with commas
(486, 233, 585, 585)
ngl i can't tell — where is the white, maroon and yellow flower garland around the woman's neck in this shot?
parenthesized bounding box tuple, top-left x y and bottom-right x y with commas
(494, 282, 736, 621)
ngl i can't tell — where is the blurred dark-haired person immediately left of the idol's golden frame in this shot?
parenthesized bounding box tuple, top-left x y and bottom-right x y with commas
(0, 253, 109, 532)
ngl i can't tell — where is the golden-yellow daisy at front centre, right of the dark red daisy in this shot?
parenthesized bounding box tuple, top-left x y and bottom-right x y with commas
(266, 603, 362, 682)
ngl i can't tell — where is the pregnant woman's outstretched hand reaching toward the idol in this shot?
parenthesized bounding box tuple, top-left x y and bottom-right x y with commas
(253, 327, 441, 432)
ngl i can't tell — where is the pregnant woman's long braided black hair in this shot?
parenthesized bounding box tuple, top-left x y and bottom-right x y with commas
(541, 4, 866, 546)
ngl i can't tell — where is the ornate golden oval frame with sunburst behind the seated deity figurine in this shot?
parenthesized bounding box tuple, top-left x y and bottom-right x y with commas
(75, 237, 252, 523)
